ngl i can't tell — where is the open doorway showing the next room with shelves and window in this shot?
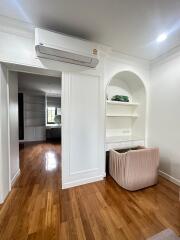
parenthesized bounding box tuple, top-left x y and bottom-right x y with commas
(8, 71, 62, 187)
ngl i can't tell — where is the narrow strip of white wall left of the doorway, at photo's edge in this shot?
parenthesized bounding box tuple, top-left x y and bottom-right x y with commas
(0, 64, 10, 203)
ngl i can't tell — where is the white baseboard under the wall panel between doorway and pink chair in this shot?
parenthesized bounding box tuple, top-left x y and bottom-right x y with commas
(62, 174, 106, 189)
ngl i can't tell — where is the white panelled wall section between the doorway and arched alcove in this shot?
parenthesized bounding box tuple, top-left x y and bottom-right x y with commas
(62, 73, 105, 188)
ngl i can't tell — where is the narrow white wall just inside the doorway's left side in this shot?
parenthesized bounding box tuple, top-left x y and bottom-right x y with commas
(8, 72, 19, 183)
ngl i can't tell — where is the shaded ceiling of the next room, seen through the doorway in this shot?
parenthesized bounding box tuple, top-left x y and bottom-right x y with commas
(18, 73, 61, 96)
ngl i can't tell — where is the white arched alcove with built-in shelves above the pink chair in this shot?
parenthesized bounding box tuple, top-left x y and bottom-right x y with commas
(106, 71, 146, 150)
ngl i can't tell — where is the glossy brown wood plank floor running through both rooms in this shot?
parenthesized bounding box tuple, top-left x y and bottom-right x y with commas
(0, 143, 180, 240)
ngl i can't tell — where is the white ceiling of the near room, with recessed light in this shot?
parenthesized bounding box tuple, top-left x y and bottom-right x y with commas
(0, 0, 180, 60)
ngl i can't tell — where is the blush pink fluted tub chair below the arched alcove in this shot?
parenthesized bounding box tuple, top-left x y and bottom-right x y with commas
(109, 148, 159, 191)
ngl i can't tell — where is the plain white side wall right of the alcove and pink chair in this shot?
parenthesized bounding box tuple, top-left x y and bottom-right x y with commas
(148, 54, 180, 185)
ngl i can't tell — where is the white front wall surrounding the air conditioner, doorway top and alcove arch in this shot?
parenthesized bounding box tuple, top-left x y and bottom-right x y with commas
(0, 16, 149, 202)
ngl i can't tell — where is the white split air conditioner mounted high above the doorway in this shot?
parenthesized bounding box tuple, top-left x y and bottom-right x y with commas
(35, 28, 99, 68)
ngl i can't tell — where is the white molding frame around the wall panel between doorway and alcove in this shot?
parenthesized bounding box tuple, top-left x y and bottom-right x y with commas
(61, 73, 105, 189)
